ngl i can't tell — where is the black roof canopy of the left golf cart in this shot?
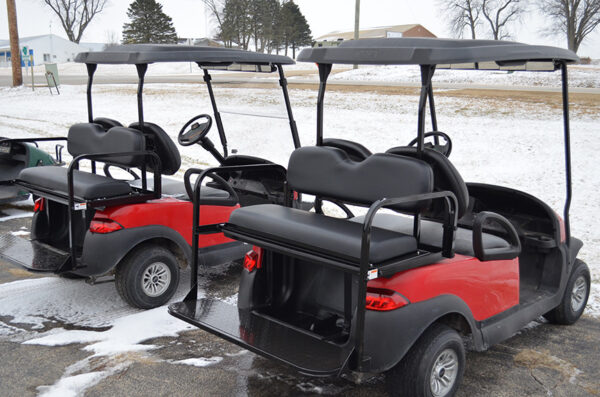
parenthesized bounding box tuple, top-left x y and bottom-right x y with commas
(75, 44, 294, 66)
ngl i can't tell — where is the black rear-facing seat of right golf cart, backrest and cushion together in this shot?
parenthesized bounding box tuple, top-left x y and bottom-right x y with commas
(224, 146, 433, 264)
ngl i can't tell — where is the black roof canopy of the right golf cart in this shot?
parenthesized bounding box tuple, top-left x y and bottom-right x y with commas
(297, 38, 579, 69)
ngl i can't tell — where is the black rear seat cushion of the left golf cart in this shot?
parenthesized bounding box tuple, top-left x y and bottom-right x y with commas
(17, 166, 131, 200)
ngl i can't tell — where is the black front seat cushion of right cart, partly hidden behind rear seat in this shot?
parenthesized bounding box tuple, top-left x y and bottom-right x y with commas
(352, 214, 510, 257)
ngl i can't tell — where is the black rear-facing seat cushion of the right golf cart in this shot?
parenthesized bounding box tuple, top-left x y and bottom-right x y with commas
(229, 204, 417, 264)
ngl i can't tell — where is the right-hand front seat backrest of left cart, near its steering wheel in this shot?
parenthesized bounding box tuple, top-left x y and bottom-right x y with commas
(129, 121, 181, 175)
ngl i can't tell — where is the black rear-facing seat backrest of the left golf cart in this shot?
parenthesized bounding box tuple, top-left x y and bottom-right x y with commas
(67, 123, 148, 167)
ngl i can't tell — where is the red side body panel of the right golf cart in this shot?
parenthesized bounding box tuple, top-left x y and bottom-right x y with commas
(368, 255, 519, 321)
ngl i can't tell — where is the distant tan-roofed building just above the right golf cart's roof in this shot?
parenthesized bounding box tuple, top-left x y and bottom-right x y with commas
(315, 24, 436, 47)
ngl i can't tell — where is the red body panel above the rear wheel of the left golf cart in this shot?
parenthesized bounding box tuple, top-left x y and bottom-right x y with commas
(94, 198, 239, 248)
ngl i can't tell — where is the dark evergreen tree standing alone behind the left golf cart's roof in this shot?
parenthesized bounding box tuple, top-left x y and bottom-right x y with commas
(123, 0, 177, 44)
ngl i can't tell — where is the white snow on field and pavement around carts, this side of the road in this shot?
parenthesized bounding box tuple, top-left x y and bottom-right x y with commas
(0, 69, 600, 395)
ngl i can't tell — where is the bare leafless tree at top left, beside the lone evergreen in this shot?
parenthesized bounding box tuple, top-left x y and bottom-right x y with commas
(44, 0, 108, 43)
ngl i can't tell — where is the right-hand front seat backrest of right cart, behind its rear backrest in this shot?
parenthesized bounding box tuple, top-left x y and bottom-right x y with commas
(386, 146, 469, 218)
